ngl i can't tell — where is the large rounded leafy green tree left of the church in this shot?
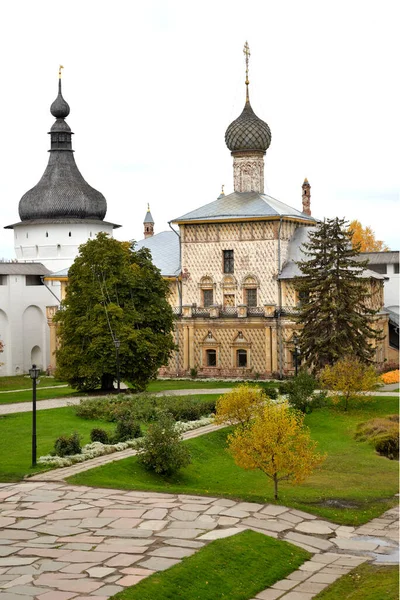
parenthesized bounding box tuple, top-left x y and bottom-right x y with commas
(56, 233, 175, 390)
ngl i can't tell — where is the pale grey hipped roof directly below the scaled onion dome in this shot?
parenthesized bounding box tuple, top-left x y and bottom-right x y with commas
(172, 192, 315, 223)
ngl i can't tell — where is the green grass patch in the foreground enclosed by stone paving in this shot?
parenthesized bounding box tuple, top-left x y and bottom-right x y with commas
(112, 531, 310, 600)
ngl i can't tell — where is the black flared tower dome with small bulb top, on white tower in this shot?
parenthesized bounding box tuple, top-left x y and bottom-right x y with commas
(19, 79, 107, 222)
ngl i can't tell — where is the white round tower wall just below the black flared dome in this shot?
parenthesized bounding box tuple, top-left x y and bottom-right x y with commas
(14, 221, 113, 272)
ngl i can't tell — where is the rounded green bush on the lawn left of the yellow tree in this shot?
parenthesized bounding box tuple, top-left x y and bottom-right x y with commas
(137, 412, 191, 475)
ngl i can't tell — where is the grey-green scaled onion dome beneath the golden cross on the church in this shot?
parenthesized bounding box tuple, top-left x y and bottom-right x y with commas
(225, 97, 271, 152)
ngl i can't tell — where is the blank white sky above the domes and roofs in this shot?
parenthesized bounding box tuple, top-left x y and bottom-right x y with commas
(0, 0, 400, 258)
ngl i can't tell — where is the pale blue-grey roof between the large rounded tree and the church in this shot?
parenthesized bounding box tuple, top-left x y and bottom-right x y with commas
(135, 231, 181, 277)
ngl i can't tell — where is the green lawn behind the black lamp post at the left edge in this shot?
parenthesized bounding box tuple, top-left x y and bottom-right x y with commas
(0, 407, 115, 482)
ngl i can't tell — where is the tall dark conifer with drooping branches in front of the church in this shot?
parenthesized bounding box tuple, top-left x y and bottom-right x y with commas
(295, 218, 381, 371)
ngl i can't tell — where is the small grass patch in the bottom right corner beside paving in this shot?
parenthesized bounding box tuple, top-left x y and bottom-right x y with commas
(314, 564, 399, 600)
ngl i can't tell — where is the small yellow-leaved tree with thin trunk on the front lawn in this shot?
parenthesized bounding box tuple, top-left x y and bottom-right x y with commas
(228, 400, 326, 500)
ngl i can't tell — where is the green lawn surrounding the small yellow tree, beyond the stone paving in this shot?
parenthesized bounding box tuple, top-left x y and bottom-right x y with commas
(69, 397, 398, 525)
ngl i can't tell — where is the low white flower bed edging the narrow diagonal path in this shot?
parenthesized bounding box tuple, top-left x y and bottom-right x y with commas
(38, 417, 214, 468)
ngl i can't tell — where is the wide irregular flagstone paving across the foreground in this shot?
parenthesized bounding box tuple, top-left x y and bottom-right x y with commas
(0, 481, 398, 600)
